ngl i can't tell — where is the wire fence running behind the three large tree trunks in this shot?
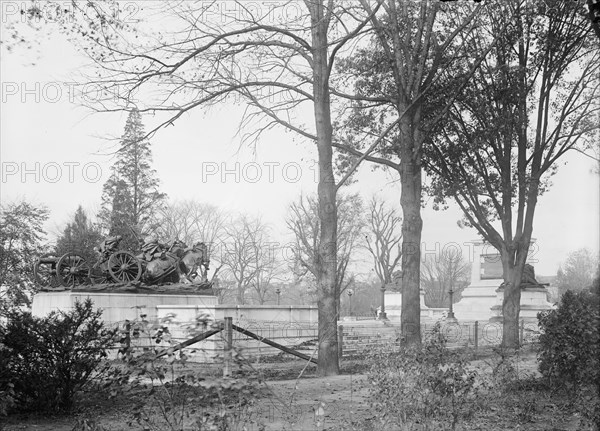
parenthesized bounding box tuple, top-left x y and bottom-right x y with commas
(118, 317, 539, 363)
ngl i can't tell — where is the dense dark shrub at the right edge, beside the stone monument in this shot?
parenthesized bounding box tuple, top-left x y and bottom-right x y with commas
(538, 291, 600, 388)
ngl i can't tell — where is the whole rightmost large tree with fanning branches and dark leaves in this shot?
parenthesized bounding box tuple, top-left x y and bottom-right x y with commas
(424, 0, 600, 347)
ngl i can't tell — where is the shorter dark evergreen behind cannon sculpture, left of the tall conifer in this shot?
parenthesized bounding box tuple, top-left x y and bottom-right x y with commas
(56, 205, 102, 265)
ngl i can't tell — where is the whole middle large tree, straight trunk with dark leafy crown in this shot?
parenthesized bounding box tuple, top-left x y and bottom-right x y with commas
(334, 0, 481, 344)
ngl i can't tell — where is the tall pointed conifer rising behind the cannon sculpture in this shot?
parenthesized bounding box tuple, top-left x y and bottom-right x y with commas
(99, 109, 166, 250)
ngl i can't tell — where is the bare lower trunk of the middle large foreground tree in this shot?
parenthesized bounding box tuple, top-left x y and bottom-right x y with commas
(400, 120, 423, 345)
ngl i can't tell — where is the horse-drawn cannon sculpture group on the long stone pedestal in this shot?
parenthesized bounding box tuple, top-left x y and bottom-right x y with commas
(34, 236, 210, 290)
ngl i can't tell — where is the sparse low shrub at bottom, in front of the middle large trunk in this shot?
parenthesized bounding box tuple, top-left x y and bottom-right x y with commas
(369, 326, 482, 429)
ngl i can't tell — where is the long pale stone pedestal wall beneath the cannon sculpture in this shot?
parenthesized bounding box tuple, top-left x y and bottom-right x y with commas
(32, 291, 318, 362)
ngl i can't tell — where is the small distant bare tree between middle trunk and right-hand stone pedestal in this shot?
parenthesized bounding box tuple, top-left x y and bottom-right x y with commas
(421, 247, 471, 308)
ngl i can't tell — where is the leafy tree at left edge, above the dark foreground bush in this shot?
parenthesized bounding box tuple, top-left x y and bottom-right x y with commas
(0, 201, 48, 316)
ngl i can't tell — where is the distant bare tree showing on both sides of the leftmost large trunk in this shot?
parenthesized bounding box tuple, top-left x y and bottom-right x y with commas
(286, 194, 365, 312)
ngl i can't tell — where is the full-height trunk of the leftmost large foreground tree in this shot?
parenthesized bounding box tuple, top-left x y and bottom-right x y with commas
(310, 2, 340, 376)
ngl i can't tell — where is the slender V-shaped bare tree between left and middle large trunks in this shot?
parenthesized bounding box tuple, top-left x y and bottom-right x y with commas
(365, 197, 402, 286)
